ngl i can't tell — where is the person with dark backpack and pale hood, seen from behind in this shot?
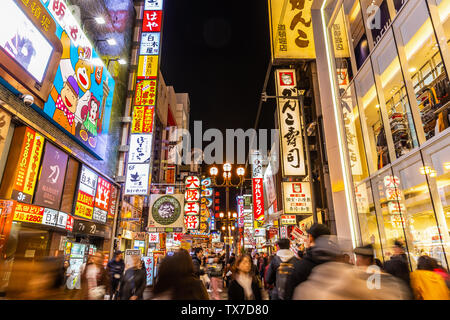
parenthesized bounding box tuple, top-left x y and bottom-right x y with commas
(266, 239, 301, 300)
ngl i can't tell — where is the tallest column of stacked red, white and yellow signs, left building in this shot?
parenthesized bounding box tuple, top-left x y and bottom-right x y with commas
(125, 0, 163, 195)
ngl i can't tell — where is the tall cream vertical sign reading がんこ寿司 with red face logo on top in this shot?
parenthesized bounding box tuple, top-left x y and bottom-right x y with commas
(275, 69, 305, 176)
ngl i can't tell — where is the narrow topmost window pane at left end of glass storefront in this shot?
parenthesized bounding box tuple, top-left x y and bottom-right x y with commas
(344, 0, 370, 69)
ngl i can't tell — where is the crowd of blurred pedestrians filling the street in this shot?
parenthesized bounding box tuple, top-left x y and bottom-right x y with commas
(1, 224, 450, 300)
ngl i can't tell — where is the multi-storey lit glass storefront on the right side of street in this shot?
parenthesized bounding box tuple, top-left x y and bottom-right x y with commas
(327, 0, 450, 270)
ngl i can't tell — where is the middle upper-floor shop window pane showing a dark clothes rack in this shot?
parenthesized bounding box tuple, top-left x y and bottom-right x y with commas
(372, 31, 419, 158)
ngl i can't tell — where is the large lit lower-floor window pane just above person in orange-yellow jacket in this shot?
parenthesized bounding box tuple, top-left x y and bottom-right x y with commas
(389, 153, 447, 269)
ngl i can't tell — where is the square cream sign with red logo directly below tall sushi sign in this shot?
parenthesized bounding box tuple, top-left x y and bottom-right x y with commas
(283, 182, 312, 214)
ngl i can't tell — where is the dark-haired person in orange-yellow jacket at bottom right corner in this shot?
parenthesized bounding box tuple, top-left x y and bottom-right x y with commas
(411, 255, 450, 300)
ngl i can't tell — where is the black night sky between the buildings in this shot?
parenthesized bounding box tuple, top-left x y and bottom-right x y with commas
(161, 0, 274, 134)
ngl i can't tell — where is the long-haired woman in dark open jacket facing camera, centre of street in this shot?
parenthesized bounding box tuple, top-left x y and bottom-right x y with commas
(228, 255, 262, 300)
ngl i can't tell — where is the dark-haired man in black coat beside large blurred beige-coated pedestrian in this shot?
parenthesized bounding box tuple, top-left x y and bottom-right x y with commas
(280, 223, 331, 298)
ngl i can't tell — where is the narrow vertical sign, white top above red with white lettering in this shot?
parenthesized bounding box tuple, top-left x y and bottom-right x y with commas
(252, 154, 264, 226)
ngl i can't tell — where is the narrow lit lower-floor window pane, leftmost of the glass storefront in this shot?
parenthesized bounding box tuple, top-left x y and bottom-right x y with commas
(355, 182, 383, 262)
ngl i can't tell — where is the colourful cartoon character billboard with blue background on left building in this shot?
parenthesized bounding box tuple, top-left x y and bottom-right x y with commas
(41, 0, 115, 159)
